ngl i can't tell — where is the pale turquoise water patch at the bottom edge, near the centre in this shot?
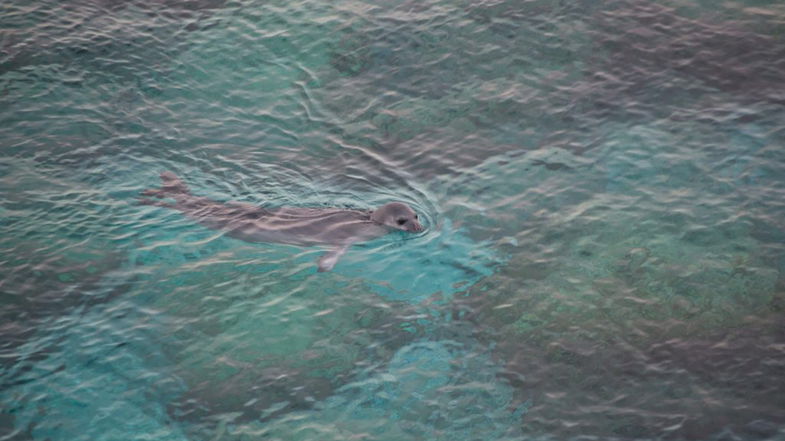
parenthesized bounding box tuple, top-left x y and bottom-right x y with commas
(185, 340, 527, 440)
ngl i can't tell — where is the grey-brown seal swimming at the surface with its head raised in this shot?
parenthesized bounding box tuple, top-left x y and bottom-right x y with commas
(139, 171, 423, 272)
